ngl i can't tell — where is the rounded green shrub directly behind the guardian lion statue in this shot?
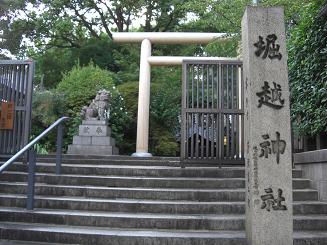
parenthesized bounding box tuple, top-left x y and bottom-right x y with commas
(57, 63, 131, 151)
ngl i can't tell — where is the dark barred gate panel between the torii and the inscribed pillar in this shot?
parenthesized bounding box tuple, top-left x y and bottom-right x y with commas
(181, 59, 244, 165)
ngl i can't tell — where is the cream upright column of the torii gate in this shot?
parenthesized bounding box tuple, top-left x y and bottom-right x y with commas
(132, 39, 152, 157)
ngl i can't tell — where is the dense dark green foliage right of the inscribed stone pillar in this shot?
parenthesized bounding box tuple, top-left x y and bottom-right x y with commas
(288, 1, 327, 135)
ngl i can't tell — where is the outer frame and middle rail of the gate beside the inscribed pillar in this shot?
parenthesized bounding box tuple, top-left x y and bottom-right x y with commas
(180, 57, 245, 167)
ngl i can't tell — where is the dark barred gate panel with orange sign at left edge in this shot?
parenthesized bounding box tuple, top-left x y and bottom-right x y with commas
(0, 60, 34, 155)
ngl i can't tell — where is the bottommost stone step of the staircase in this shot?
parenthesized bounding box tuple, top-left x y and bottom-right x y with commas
(0, 222, 327, 245)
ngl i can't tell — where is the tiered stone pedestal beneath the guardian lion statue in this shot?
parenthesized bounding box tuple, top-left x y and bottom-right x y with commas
(68, 120, 119, 155)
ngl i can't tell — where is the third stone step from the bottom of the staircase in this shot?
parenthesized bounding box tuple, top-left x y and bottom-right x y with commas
(0, 194, 327, 215)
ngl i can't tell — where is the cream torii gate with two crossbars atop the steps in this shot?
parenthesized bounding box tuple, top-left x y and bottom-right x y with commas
(113, 32, 231, 157)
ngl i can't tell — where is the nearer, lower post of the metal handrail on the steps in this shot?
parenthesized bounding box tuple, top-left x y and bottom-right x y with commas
(26, 149, 36, 210)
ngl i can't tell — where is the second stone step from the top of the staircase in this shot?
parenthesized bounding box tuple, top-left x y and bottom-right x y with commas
(3, 163, 302, 178)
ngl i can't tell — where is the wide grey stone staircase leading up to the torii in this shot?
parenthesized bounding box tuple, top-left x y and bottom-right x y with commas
(0, 155, 327, 245)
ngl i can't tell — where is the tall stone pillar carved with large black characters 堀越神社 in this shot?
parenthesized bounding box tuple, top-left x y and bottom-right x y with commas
(242, 7, 293, 245)
